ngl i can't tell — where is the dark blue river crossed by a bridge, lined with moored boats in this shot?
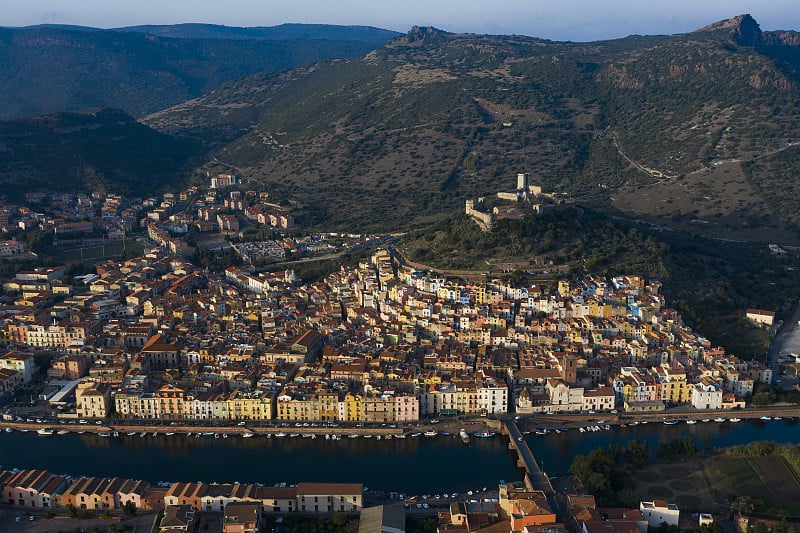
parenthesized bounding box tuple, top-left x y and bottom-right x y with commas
(0, 420, 800, 494)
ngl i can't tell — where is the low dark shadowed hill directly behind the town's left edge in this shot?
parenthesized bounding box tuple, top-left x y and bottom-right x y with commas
(0, 109, 205, 199)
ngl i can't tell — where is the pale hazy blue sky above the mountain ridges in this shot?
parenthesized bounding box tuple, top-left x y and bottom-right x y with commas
(6, 0, 800, 41)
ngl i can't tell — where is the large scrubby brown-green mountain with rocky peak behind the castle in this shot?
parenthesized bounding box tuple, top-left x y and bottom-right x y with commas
(146, 15, 800, 238)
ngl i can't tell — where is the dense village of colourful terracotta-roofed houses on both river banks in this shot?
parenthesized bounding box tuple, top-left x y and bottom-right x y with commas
(0, 176, 799, 532)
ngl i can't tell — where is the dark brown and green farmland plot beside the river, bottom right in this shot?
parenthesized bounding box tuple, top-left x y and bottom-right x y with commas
(636, 455, 800, 516)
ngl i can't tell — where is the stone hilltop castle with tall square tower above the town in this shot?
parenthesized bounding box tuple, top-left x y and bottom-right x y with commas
(465, 172, 574, 231)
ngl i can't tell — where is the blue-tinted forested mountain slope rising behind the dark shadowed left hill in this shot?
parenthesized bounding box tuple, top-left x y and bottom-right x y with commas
(0, 25, 393, 119)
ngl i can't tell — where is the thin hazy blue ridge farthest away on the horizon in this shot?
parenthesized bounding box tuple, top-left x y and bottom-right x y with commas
(114, 24, 400, 45)
